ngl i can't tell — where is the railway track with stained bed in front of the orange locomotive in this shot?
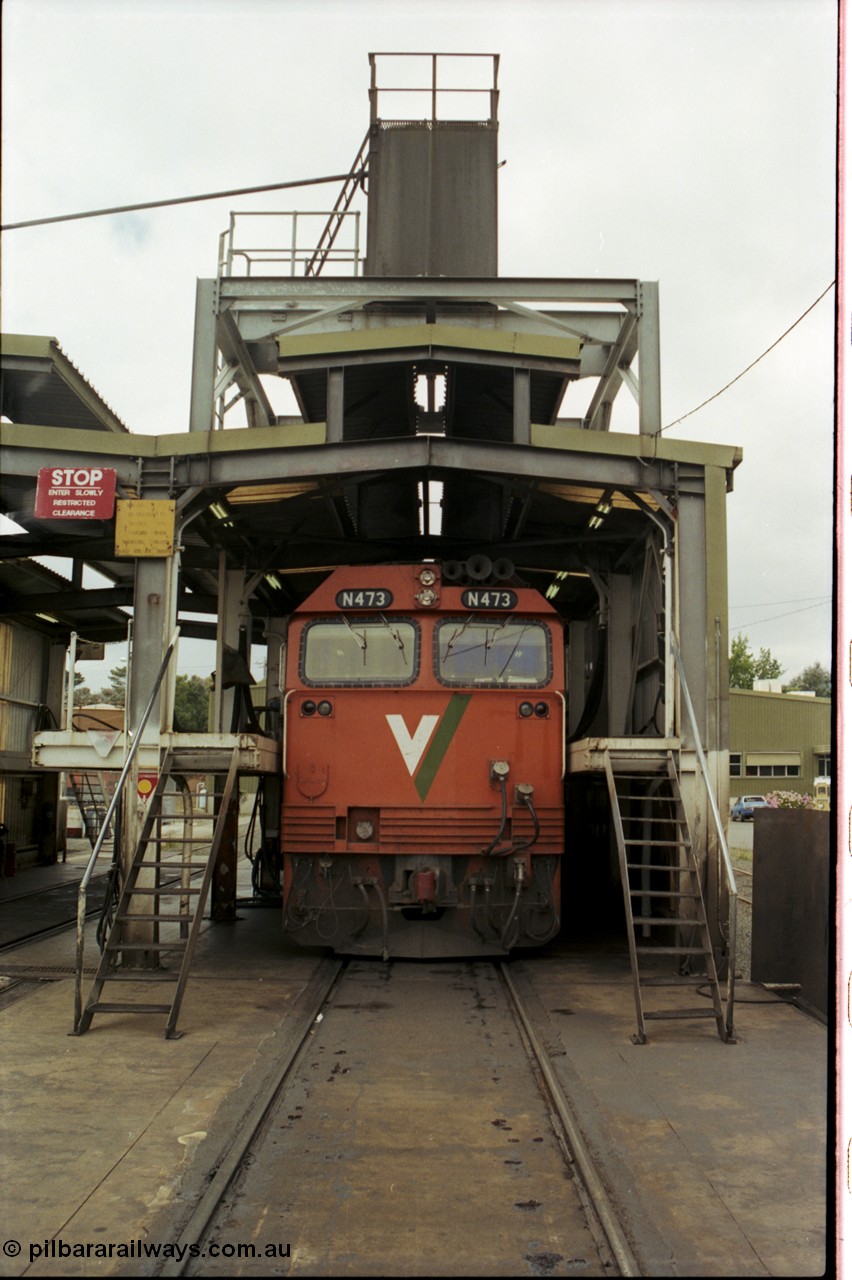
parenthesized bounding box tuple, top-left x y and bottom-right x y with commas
(157, 960, 641, 1276)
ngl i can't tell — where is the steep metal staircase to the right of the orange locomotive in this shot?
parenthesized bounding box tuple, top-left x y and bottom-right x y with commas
(604, 748, 730, 1044)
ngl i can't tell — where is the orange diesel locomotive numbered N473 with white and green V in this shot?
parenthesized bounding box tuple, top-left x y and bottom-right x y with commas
(281, 557, 565, 959)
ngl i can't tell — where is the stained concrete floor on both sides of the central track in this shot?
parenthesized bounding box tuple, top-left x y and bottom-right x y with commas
(0, 860, 833, 1276)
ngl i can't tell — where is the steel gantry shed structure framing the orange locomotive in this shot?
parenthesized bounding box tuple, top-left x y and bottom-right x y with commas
(0, 55, 741, 1039)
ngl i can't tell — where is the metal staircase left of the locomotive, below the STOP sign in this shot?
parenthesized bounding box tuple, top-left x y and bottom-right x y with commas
(74, 749, 239, 1039)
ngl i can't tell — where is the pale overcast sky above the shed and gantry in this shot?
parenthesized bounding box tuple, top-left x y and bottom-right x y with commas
(3, 0, 837, 687)
